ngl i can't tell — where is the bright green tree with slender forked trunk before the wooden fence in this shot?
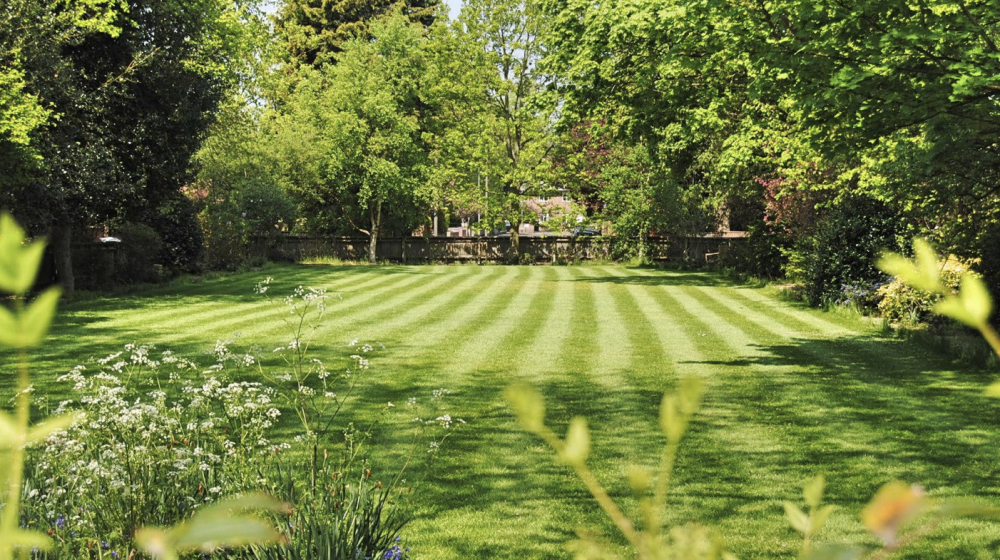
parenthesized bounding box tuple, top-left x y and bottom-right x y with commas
(285, 12, 426, 262)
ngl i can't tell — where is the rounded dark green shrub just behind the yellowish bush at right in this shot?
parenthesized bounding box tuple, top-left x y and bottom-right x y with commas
(805, 194, 903, 305)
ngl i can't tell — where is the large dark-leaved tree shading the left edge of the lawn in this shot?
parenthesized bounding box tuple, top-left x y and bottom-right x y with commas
(3, 0, 266, 290)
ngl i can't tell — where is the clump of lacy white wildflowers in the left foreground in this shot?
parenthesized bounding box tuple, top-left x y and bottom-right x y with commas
(23, 344, 288, 553)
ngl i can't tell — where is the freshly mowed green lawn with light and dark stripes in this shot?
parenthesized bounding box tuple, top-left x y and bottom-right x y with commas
(11, 266, 1000, 560)
